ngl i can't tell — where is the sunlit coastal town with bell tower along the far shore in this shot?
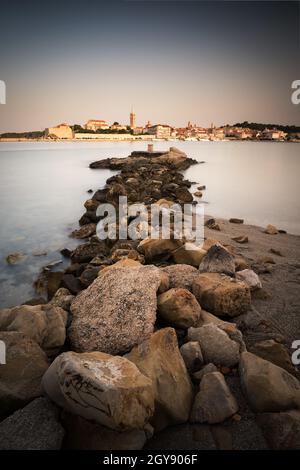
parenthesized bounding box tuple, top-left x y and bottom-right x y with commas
(0, 110, 300, 142)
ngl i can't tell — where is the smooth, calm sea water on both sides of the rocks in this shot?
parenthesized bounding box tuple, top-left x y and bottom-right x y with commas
(0, 142, 300, 307)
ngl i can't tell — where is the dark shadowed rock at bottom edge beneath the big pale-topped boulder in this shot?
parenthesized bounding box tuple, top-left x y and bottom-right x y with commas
(62, 412, 152, 451)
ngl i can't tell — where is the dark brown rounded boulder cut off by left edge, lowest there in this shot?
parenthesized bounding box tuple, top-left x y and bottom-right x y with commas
(0, 331, 49, 417)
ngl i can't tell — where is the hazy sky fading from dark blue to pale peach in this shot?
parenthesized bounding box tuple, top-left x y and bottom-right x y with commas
(0, 0, 300, 132)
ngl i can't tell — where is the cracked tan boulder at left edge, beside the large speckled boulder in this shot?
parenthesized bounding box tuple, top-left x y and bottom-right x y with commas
(0, 304, 67, 356)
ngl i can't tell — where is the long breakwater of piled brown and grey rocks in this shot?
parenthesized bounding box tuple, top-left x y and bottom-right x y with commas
(0, 148, 300, 450)
